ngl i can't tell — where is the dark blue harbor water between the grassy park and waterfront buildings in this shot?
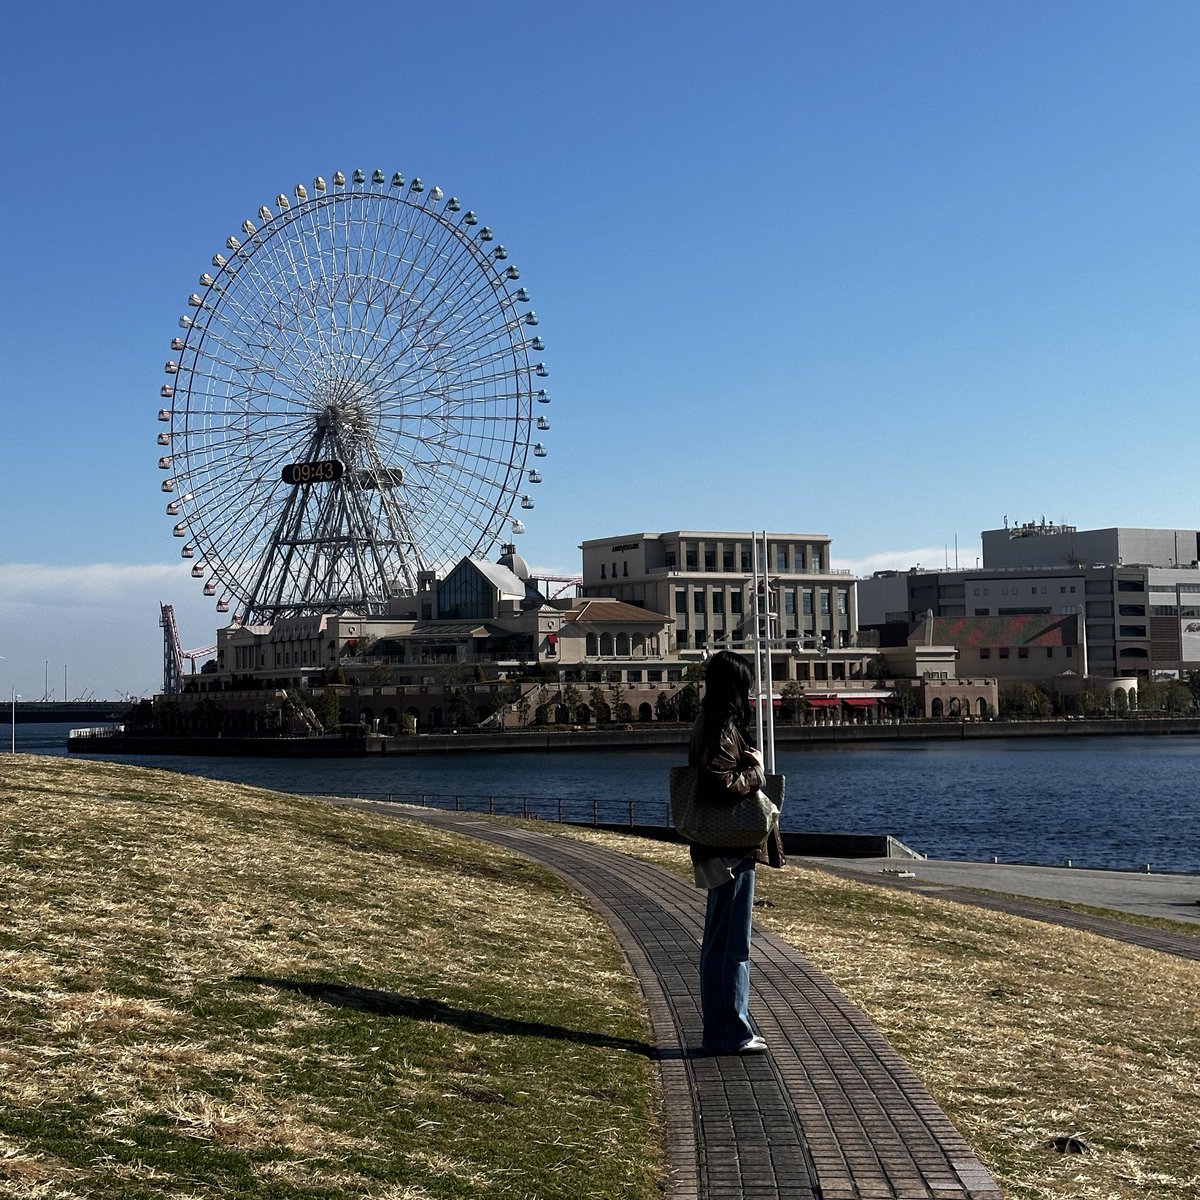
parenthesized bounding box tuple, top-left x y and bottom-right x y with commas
(16, 725, 1200, 872)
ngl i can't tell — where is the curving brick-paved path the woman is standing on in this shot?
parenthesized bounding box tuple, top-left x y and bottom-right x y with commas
(338, 800, 1001, 1200)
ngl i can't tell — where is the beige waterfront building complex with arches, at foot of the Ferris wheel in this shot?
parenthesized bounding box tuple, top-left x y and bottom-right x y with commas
(159, 532, 996, 732)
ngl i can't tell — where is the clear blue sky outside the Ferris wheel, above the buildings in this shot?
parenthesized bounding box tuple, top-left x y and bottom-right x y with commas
(0, 0, 1200, 696)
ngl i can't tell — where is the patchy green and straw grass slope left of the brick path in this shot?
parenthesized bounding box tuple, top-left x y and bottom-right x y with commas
(0, 756, 660, 1200)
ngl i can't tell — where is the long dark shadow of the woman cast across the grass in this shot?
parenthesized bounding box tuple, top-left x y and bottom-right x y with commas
(234, 974, 664, 1058)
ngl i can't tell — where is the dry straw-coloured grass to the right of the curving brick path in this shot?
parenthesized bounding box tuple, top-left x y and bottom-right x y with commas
(561, 830, 1200, 1200)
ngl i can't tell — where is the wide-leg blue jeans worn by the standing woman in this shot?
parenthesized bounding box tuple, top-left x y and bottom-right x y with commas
(700, 858, 755, 1054)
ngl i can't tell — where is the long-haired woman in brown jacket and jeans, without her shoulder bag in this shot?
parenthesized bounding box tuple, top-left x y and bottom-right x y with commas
(688, 650, 784, 1054)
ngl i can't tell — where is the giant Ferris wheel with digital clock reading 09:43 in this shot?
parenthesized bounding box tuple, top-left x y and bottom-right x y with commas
(158, 170, 550, 623)
